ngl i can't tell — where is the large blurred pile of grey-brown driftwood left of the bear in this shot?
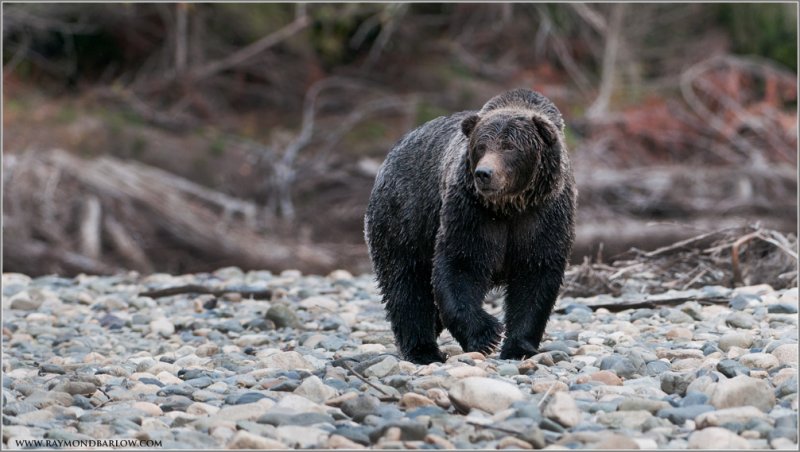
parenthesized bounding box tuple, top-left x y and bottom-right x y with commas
(3, 150, 333, 274)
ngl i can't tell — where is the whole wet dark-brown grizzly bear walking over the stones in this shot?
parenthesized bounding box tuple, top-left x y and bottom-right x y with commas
(364, 89, 577, 364)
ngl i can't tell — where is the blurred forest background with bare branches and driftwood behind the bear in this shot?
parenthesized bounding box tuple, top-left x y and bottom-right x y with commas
(3, 3, 797, 275)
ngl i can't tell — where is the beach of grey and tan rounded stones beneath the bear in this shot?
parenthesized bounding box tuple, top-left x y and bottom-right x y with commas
(2, 268, 798, 450)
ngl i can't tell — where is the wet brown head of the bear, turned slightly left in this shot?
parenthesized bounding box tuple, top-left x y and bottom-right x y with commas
(461, 110, 564, 208)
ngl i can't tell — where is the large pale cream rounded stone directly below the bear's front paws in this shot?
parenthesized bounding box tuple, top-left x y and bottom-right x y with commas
(449, 377, 524, 414)
